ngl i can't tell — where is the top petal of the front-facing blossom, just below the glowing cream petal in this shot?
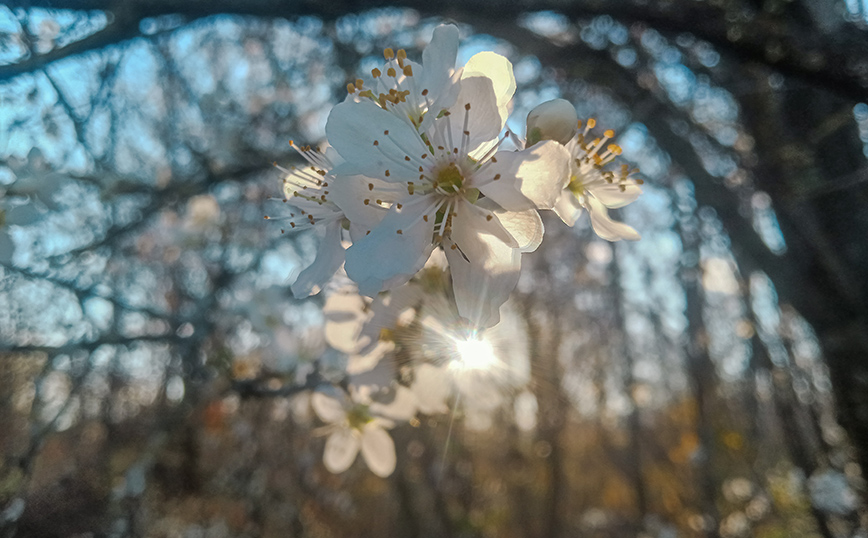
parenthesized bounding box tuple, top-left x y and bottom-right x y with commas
(444, 76, 506, 155)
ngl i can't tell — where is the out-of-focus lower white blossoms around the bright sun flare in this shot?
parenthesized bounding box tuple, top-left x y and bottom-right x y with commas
(311, 255, 530, 476)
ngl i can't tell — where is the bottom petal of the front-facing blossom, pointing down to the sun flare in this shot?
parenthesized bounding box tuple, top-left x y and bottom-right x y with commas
(446, 201, 521, 328)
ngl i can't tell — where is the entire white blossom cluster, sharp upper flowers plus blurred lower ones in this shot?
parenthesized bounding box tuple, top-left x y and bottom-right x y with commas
(266, 25, 641, 475)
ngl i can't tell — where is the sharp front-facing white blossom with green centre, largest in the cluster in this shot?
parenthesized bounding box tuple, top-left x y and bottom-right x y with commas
(326, 35, 569, 327)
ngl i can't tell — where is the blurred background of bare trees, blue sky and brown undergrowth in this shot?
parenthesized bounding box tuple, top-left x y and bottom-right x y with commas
(0, 0, 868, 538)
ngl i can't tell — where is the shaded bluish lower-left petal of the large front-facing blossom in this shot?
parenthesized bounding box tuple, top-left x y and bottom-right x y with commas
(345, 196, 437, 295)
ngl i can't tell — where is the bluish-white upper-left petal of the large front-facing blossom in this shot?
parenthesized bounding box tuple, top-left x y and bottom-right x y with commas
(326, 101, 428, 181)
